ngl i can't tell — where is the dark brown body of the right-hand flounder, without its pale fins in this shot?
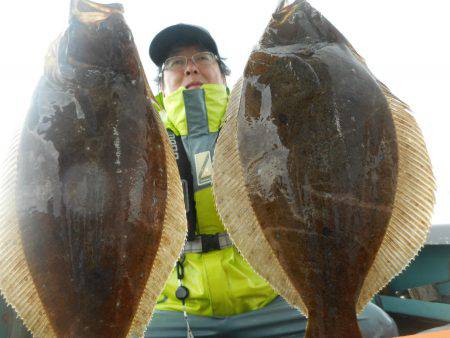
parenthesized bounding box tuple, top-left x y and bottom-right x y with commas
(238, 1, 398, 337)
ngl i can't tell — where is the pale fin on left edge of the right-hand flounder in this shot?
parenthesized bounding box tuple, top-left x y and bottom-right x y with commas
(213, 78, 307, 314)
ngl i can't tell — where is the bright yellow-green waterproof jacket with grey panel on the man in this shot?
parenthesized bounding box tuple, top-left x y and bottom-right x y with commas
(156, 84, 277, 316)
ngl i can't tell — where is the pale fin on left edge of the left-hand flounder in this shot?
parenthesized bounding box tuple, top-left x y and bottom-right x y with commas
(0, 133, 56, 337)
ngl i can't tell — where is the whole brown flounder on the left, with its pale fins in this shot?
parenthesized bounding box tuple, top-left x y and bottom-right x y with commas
(0, 0, 186, 338)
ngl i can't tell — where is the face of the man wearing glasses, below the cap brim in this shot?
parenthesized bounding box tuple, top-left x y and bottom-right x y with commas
(161, 46, 225, 96)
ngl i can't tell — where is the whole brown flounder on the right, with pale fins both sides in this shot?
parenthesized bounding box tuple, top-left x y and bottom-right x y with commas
(213, 1, 434, 337)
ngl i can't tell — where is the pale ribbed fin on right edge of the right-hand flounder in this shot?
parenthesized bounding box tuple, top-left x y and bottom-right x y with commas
(357, 82, 436, 312)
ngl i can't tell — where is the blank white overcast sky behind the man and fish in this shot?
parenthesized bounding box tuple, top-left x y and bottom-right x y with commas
(0, 0, 450, 224)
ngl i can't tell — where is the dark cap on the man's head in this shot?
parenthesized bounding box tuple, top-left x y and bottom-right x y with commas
(149, 23, 219, 67)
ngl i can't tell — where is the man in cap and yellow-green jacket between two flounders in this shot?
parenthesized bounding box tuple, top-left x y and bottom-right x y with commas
(146, 24, 397, 338)
